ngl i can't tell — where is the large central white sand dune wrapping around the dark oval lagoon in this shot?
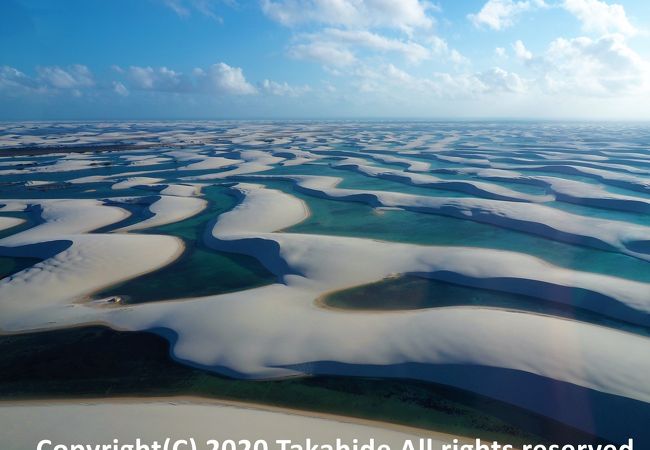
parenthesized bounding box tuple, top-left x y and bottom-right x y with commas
(0, 185, 650, 442)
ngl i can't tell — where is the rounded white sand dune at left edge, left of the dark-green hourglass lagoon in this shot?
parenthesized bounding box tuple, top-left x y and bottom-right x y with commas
(0, 234, 183, 322)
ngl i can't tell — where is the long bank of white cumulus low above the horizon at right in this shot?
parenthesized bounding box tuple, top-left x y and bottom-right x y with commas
(340, 34, 650, 101)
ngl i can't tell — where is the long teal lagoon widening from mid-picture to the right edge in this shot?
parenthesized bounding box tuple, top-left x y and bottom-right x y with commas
(256, 179, 650, 282)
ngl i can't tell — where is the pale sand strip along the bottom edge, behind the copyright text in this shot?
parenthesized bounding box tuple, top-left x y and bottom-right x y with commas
(0, 397, 456, 450)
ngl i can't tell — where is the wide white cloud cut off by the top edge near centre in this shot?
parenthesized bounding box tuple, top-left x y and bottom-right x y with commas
(262, 0, 435, 32)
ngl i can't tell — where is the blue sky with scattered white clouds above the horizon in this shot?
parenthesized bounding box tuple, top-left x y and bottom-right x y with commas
(0, 0, 650, 120)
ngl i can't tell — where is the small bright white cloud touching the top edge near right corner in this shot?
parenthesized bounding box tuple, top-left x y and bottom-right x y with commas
(562, 0, 637, 35)
